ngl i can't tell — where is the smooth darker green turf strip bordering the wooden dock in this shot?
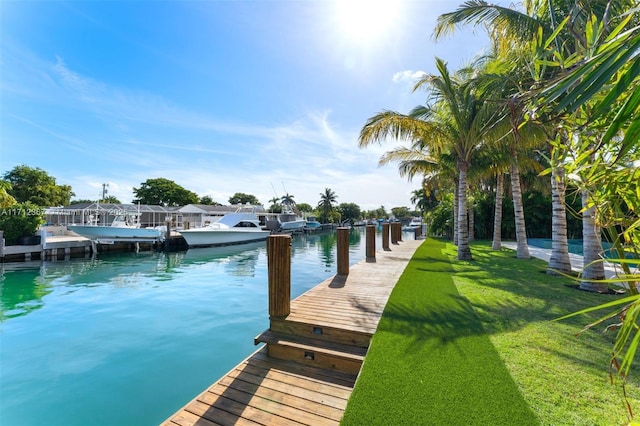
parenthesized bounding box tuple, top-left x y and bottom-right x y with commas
(342, 239, 540, 425)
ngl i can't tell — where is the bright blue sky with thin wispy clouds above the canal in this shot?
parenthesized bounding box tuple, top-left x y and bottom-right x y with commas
(0, 0, 500, 211)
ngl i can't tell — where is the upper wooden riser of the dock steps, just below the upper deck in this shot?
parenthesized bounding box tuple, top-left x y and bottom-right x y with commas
(270, 318, 372, 348)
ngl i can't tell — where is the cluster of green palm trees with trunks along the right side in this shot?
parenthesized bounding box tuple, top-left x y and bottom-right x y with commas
(359, 0, 640, 406)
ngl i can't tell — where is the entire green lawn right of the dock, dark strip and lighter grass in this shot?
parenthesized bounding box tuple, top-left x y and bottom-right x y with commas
(343, 239, 640, 425)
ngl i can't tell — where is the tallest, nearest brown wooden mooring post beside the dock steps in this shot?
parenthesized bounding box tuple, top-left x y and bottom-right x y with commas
(267, 235, 291, 318)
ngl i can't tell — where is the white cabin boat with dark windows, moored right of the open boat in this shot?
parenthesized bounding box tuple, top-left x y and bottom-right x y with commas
(179, 209, 270, 247)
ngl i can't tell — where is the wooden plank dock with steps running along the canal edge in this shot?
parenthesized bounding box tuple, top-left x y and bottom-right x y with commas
(163, 240, 422, 426)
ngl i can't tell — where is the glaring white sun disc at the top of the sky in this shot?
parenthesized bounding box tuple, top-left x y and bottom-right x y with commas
(336, 0, 400, 44)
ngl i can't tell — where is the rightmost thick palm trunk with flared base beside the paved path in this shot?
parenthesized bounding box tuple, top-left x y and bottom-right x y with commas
(580, 190, 608, 293)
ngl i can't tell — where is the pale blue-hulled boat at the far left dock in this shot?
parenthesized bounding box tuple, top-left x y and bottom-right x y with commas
(67, 215, 165, 242)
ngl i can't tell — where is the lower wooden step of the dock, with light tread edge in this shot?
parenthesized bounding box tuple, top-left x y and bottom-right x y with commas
(254, 330, 367, 375)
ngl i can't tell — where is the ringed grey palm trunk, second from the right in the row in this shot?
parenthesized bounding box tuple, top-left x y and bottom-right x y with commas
(547, 165, 571, 275)
